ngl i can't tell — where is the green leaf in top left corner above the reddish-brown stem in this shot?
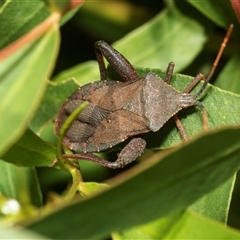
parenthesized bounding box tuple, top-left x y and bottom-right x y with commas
(0, 0, 49, 48)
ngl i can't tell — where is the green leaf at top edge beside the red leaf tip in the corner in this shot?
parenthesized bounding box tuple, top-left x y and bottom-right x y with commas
(187, 0, 237, 28)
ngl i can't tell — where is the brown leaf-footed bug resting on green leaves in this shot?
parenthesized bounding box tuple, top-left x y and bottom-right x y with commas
(54, 25, 233, 168)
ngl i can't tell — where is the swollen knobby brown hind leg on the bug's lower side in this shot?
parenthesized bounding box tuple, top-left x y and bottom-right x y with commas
(63, 138, 146, 168)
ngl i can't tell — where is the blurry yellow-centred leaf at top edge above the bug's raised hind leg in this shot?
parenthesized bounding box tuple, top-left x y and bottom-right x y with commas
(74, 0, 154, 42)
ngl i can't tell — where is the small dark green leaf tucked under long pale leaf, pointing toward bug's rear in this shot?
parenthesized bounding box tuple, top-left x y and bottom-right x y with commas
(2, 130, 56, 167)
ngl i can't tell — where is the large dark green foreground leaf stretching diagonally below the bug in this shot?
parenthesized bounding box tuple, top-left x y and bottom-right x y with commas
(29, 127, 240, 239)
